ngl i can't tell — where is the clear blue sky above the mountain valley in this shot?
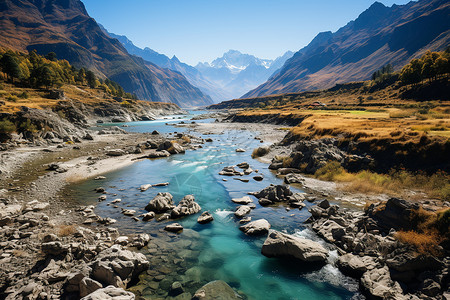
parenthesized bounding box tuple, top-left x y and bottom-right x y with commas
(82, 0, 409, 65)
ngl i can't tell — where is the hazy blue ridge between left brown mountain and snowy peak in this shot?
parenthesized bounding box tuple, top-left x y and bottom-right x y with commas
(102, 27, 232, 102)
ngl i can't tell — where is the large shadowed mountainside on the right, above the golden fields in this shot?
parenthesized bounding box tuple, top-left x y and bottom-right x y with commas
(243, 0, 450, 97)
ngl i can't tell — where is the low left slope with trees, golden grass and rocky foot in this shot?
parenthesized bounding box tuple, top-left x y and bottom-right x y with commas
(0, 50, 182, 142)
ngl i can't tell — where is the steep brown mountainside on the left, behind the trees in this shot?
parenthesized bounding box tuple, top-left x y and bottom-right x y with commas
(0, 0, 212, 107)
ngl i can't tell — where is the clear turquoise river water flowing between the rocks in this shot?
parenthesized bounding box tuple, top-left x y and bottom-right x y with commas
(72, 111, 358, 300)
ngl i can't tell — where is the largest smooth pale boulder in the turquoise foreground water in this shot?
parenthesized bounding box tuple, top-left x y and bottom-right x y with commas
(261, 230, 328, 263)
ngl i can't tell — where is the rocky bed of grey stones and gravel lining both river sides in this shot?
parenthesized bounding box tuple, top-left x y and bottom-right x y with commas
(0, 111, 449, 299)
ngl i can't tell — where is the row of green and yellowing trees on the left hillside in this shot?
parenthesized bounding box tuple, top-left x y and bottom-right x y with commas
(0, 50, 137, 99)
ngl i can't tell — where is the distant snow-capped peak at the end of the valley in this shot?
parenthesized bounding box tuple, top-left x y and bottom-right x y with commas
(196, 50, 293, 99)
